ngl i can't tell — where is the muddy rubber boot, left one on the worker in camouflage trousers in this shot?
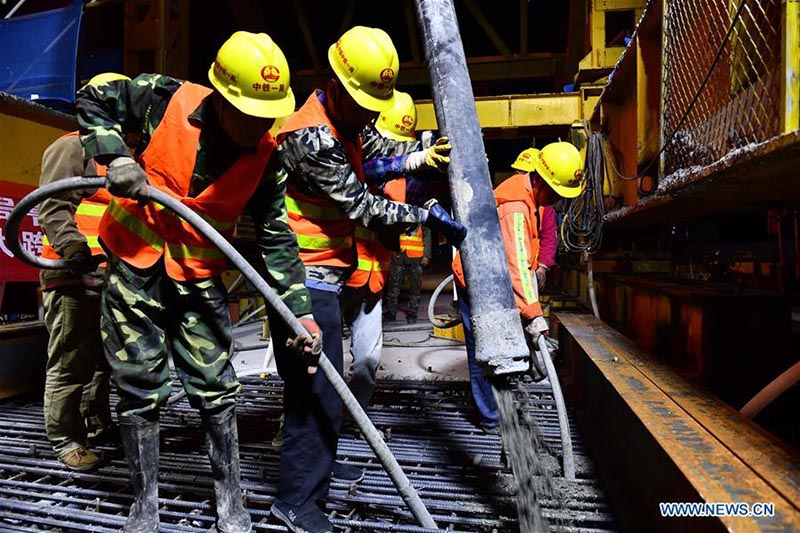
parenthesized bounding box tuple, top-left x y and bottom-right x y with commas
(119, 417, 159, 533)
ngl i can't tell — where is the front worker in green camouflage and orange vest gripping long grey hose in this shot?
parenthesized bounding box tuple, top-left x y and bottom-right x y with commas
(76, 32, 321, 532)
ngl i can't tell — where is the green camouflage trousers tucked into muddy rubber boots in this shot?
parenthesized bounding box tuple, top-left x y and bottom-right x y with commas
(101, 258, 240, 420)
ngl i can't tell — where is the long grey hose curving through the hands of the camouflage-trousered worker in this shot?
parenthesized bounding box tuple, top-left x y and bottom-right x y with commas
(6, 177, 437, 529)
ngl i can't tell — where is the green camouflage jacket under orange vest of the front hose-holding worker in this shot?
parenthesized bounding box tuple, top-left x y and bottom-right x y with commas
(75, 74, 311, 316)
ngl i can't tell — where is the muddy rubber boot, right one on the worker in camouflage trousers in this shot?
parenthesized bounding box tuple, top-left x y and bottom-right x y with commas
(206, 411, 253, 533)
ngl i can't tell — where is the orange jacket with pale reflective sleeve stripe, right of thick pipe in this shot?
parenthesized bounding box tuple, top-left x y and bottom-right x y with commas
(452, 173, 542, 318)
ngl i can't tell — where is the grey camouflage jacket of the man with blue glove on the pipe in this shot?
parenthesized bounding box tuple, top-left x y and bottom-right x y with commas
(278, 108, 424, 286)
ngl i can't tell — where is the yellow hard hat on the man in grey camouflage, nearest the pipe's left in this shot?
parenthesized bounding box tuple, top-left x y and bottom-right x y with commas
(328, 26, 400, 111)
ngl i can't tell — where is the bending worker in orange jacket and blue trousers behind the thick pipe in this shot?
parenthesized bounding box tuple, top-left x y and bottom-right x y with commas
(453, 142, 584, 433)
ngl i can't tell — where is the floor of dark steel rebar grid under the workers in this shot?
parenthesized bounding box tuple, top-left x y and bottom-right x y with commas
(0, 377, 619, 532)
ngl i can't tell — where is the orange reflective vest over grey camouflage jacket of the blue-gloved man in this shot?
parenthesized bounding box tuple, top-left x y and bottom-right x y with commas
(278, 90, 364, 269)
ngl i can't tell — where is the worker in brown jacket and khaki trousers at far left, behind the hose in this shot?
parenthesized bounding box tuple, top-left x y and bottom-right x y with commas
(39, 73, 130, 472)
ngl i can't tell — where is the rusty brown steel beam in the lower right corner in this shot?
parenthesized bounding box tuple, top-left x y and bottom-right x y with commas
(556, 313, 800, 531)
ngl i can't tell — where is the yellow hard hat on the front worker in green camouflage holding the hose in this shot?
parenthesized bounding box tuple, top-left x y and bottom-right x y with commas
(208, 31, 294, 118)
